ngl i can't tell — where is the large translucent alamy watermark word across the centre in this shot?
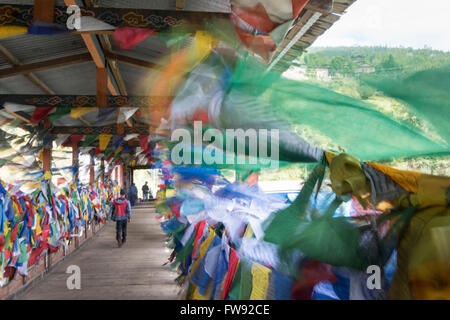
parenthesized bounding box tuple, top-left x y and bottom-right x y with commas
(171, 121, 279, 169)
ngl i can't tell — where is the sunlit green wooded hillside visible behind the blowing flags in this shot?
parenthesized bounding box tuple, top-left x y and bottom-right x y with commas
(261, 47, 450, 180)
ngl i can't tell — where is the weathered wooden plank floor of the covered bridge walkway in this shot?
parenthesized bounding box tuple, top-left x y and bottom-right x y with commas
(15, 205, 178, 300)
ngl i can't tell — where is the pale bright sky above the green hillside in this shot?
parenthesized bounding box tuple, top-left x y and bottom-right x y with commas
(313, 0, 450, 51)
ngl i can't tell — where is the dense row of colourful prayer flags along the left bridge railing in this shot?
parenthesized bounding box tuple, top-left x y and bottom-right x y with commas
(0, 179, 119, 286)
